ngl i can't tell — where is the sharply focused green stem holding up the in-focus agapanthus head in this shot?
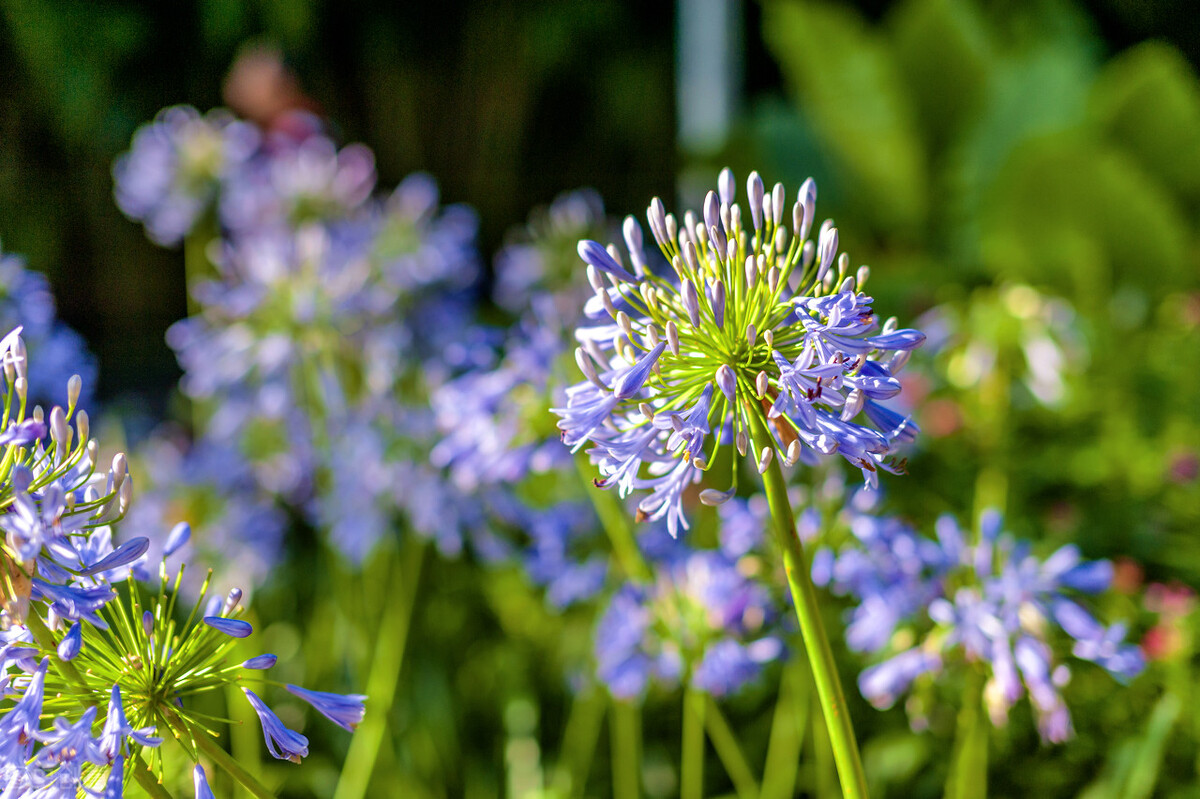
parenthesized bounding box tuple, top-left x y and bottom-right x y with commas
(749, 413, 868, 799)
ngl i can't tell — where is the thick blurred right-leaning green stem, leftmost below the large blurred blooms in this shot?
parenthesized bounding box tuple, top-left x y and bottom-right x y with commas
(334, 536, 425, 799)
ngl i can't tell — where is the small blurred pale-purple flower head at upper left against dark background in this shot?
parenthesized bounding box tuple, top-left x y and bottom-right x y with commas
(113, 106, 259, 246)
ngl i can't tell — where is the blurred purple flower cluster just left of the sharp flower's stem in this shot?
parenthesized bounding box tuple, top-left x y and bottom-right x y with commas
(595, 547, 782, 698)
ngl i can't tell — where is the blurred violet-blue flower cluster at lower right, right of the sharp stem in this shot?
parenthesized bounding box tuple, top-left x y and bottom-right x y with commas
(815, 512, 1144, 743)
